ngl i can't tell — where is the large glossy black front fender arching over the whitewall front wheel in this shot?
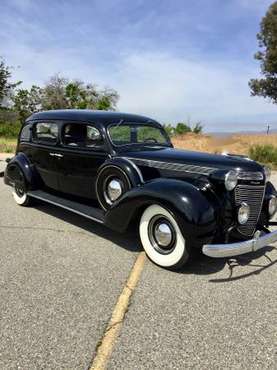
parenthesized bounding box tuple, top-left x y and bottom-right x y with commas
(105, 178, 216, 239)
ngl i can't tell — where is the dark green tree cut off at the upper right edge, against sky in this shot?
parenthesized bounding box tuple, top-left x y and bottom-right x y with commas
(249, 1, 277, 103)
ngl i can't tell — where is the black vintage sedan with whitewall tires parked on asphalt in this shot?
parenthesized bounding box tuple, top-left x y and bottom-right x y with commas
(4, 110, 277, 268)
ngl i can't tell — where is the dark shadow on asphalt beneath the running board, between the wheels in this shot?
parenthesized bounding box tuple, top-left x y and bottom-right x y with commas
(34, 201, 142, 252)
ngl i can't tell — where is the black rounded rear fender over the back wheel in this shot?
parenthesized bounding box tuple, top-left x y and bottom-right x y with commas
(4, 153, 39, 189)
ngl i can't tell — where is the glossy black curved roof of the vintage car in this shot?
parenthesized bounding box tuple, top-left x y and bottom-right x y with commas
(26, 109, 158, 126)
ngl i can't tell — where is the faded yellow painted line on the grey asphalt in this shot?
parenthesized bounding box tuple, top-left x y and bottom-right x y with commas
(90, 252, 146, 370)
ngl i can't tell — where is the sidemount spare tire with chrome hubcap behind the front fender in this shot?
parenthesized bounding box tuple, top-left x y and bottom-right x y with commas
(96, 164, 133, 211)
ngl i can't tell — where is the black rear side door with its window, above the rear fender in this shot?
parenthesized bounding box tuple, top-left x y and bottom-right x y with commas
(29, 121, 59, 190)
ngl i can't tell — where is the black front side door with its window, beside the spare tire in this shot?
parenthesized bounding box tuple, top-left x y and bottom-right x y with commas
(58, 122, 108, 199)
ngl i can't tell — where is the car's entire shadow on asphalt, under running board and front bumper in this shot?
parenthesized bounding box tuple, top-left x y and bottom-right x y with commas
(31, 202, 277, 283)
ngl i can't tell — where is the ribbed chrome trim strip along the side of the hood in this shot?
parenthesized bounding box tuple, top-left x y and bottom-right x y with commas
(124, 157, 217, 175)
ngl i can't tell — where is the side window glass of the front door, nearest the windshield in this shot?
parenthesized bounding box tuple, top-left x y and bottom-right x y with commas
(62, 123, 103, 148)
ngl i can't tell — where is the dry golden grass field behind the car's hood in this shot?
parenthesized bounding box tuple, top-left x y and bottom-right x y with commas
(172, 134, 277, 155)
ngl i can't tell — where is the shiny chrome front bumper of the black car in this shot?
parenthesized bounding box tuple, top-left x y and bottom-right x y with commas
(202, 230, 277, 258)
